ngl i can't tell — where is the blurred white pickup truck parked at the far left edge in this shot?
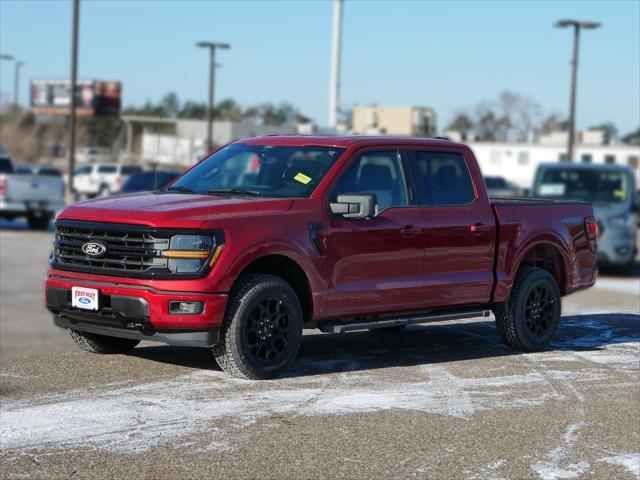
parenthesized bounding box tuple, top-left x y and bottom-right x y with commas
(0, 155, 65, 230)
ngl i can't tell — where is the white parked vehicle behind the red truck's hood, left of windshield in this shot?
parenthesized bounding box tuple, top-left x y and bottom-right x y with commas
(73, 163, 142, 197)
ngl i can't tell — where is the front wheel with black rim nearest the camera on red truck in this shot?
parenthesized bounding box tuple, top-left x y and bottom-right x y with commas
(213, 274, 303, 380)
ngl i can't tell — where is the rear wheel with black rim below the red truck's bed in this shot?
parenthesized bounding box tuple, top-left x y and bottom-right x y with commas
(494, 267, 561, 352)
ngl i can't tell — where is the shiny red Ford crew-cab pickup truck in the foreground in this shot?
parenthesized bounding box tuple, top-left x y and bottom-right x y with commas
(45, 136, 597, 379)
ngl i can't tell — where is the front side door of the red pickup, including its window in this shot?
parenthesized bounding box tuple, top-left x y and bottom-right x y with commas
(325, 150, 424, 316)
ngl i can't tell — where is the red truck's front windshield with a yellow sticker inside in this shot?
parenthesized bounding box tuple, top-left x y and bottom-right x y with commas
(168, 143, 344, 197)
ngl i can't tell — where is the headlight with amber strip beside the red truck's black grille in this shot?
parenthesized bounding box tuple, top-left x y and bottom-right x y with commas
(162, 235, 215, 273)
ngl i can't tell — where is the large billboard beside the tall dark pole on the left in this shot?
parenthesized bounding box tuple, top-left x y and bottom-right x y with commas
(31, 79, 122, 116)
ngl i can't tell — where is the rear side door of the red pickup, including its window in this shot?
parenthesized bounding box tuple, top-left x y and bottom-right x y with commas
(410, 147, 496, 307)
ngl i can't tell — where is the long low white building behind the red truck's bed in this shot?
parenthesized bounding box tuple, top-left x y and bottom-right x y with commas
(468, 142, 640, 188)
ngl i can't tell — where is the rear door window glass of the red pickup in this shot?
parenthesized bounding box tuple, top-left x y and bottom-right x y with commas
(415, 151, 476, 205)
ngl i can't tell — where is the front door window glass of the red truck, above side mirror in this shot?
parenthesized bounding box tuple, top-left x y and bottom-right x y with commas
(334, 150, 407, 212)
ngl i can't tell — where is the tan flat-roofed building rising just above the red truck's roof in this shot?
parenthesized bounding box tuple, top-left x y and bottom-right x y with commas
(351, 105, 436, 137)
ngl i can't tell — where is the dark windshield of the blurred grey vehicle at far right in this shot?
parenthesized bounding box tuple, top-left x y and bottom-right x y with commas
(534, 168, 629, 203)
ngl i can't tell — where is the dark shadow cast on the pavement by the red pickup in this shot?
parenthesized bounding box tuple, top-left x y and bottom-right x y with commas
(131, 313, 640, 378)
